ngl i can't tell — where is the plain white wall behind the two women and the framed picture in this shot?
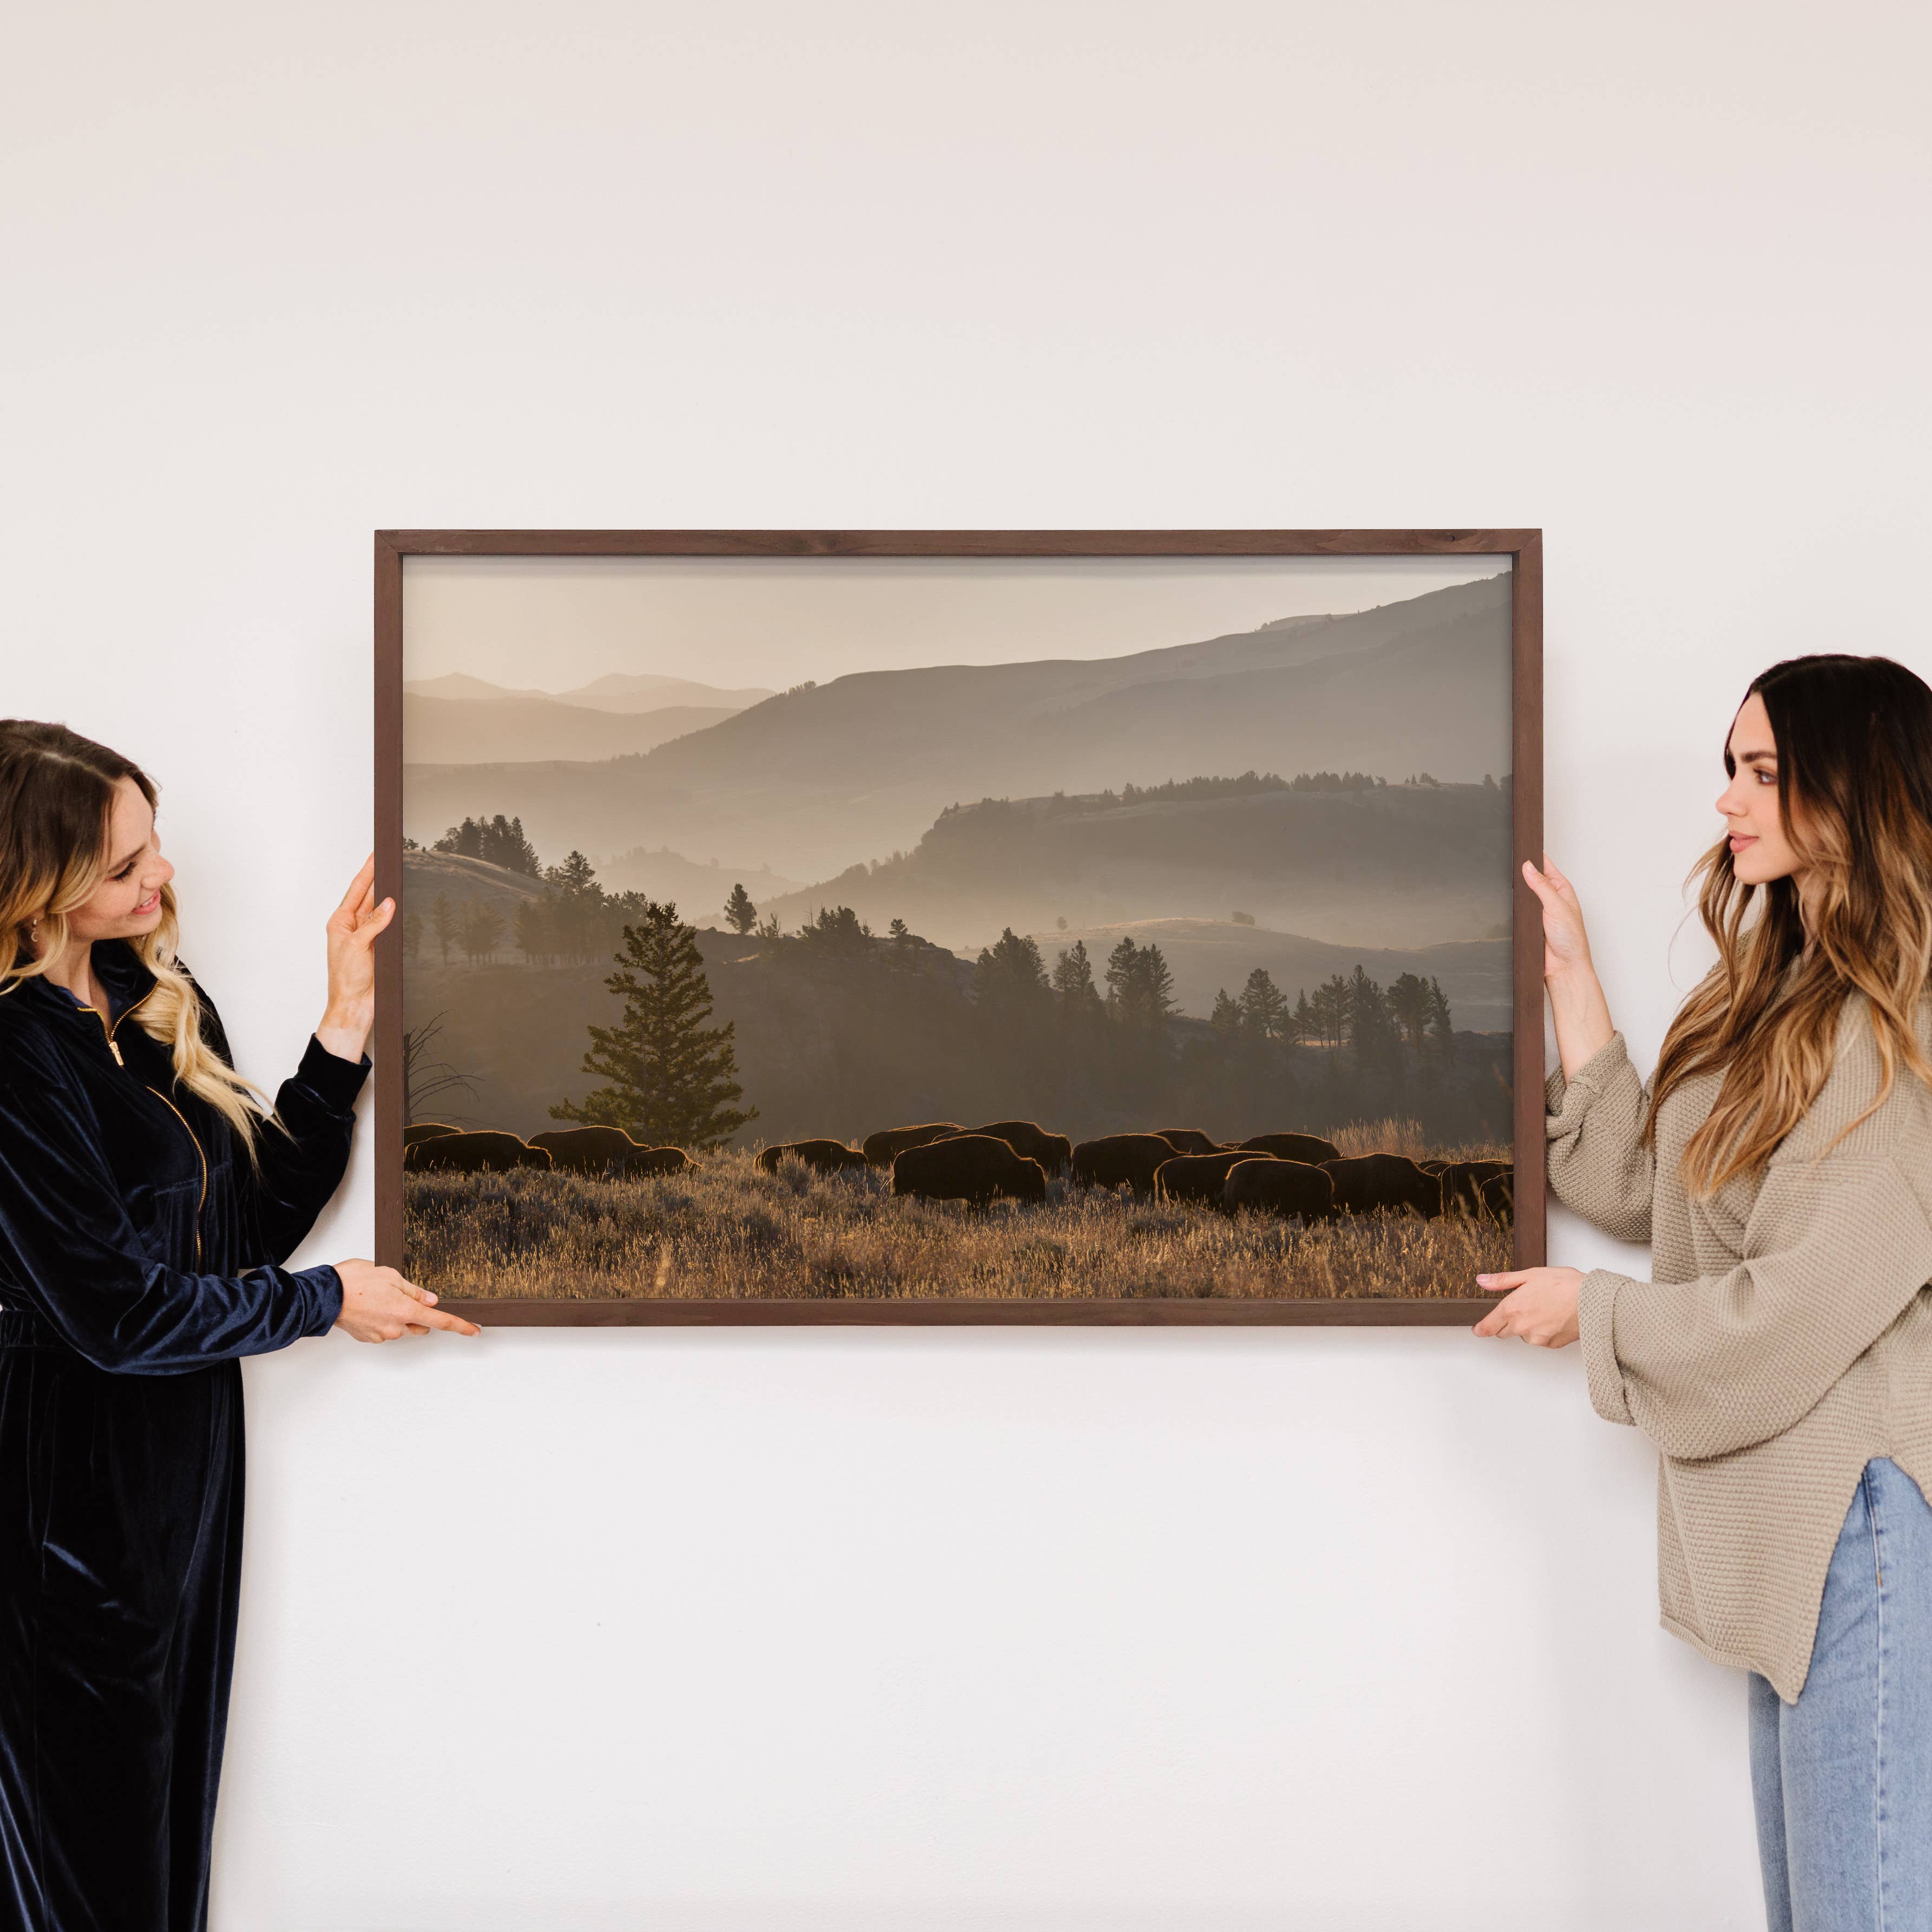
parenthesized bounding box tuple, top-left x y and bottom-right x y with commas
(0, 0, 1932, 1932)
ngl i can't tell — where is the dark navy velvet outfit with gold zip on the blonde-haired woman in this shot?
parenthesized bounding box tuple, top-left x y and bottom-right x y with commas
(0, 941, 369, 1932)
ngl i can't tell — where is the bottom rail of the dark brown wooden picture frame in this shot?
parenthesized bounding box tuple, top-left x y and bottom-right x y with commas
(437, 1294, 1499, 1328)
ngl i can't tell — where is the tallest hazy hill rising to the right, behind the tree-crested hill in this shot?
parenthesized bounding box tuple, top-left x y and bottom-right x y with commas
(404, 577, 1511, 879)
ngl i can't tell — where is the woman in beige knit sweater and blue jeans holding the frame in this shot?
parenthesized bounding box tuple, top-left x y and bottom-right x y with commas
(1478, 657, 1932, 1932)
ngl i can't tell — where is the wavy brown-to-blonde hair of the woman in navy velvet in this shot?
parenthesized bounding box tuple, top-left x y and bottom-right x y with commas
(0, 719, 272, 1161)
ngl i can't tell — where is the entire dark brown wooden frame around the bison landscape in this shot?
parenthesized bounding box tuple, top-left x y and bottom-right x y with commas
(375, 529, 1546, 1328)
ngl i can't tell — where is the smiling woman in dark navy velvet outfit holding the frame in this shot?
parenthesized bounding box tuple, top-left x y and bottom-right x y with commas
(0, 719, 477, 1932)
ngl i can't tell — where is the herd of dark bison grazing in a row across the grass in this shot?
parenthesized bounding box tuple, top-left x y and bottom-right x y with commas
(402, 1121, 1515, 1223)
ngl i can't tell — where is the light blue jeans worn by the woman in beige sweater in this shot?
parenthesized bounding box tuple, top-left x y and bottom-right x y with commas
(1750, 1461, 1932, 1932)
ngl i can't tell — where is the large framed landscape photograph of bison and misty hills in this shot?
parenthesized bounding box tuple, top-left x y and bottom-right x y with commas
(375, 529, 1543, 1323)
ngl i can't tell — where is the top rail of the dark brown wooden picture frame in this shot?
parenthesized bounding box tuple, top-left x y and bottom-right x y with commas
(375, 529, 1542, 556)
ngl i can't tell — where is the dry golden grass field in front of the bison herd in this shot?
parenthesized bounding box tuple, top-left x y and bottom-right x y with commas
(406, 1121, 1509, 1300)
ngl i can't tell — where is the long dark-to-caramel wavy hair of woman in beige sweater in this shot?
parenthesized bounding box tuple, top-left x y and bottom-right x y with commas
(1644, 655, 1932, 1194)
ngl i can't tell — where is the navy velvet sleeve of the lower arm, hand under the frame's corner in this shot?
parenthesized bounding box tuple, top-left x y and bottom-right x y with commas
(0, 1040, 342, 1376)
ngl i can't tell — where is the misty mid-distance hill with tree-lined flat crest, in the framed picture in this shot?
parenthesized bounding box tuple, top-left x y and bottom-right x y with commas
(761, 784, 1511, 954)
